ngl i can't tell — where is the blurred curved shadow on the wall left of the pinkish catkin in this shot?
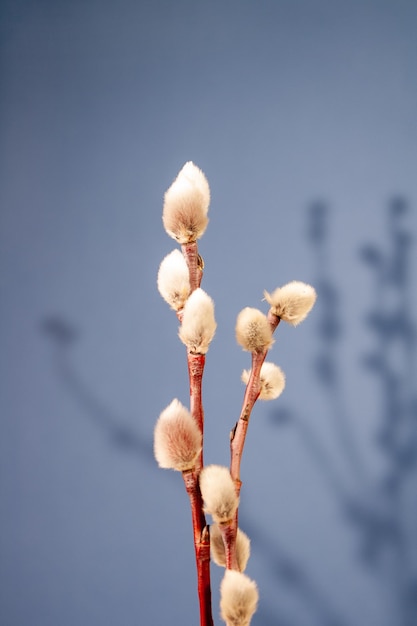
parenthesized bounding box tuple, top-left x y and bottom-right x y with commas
(41, 315, 155, 464)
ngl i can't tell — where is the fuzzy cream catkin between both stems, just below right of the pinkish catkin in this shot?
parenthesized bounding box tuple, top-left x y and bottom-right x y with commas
(200, 465, 239, 523)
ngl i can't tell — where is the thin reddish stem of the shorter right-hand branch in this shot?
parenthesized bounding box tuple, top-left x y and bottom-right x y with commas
(226, 311, 280, 570)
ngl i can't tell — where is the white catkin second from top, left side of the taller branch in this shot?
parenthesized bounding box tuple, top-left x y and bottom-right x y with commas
(157, 250, 190, 311)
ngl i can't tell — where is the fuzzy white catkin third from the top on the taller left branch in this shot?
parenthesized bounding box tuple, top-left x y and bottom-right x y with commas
(178, 287, 217, 354)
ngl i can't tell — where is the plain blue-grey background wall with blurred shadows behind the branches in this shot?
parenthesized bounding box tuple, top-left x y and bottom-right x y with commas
(0, 0, 417, 626)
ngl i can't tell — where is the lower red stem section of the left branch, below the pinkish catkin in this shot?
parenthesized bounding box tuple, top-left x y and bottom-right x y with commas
(182, 469, 213, 626)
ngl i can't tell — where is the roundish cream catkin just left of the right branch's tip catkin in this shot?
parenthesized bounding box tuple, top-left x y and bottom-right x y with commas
(236, 307, 274, 352)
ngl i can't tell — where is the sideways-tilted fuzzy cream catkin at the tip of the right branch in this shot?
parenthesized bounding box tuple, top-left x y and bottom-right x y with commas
(264, 280, 317, 326)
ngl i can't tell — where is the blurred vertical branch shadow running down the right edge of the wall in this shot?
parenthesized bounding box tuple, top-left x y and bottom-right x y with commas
(360, 196, 417, 626)
